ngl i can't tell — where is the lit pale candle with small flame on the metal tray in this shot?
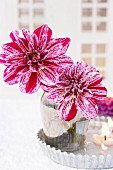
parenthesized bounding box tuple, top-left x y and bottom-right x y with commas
(93, 124, 113, 150)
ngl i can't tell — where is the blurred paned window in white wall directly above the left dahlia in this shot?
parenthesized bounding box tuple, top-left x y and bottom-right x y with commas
(17, 0, 45, 30)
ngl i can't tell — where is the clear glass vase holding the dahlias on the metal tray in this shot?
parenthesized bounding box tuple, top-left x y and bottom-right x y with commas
(41, 93, 89, 152)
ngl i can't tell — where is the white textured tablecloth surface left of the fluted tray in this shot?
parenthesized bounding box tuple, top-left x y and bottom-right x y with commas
(0, 95, 112, 170)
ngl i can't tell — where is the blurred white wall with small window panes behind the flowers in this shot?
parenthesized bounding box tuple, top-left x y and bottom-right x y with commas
(0, 0, 113, 97)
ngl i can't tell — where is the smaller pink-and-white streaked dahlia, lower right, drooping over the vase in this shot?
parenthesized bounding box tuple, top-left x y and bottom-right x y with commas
(48, 62, 107, 121)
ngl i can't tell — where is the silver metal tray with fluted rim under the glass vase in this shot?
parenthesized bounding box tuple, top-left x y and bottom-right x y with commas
(38, 116, 113, 169)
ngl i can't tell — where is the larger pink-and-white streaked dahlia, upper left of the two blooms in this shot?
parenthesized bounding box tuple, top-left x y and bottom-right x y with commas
(0, 25, 72, 93)
